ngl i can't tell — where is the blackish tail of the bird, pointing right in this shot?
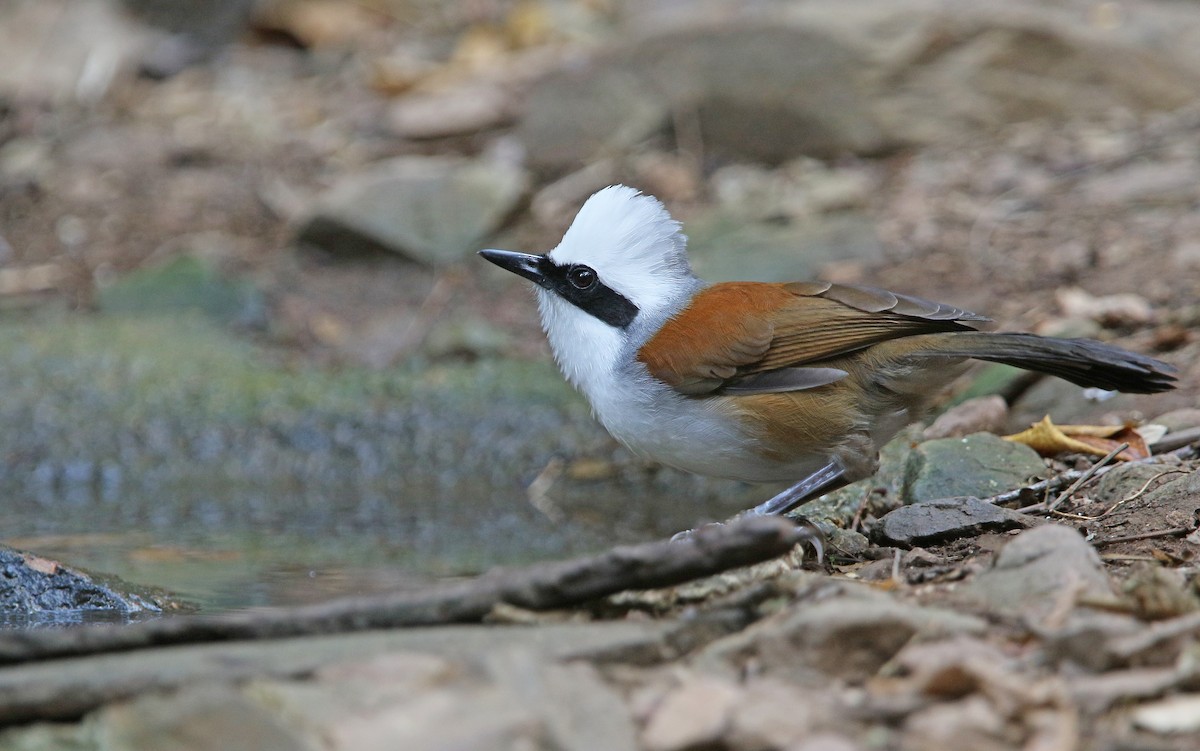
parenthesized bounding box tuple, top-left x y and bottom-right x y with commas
(923, 331, 1176, 393)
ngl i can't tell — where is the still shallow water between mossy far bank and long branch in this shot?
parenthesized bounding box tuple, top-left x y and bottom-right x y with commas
(0, 473, 756, 614)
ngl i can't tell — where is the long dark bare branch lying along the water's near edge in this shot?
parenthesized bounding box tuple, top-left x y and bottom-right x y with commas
(0, 517, 808, 665)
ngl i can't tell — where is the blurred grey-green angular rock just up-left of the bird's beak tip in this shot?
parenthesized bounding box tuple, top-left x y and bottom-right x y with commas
(296, 157, 528, 266)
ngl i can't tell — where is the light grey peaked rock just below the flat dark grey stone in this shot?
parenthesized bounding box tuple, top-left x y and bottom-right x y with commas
(966, 524, 1115, 624)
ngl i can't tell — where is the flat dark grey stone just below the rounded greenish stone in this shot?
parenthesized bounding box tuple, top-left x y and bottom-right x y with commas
(872, 498, 1031, 547)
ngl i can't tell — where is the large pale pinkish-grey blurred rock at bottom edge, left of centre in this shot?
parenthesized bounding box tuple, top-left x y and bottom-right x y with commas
(248, 648, 637, 751)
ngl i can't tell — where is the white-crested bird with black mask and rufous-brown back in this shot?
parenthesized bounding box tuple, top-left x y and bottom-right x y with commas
(480, 185, 1175, 523)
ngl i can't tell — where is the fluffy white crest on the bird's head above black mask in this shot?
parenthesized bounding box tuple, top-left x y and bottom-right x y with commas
(550, 185, 695, 314)
